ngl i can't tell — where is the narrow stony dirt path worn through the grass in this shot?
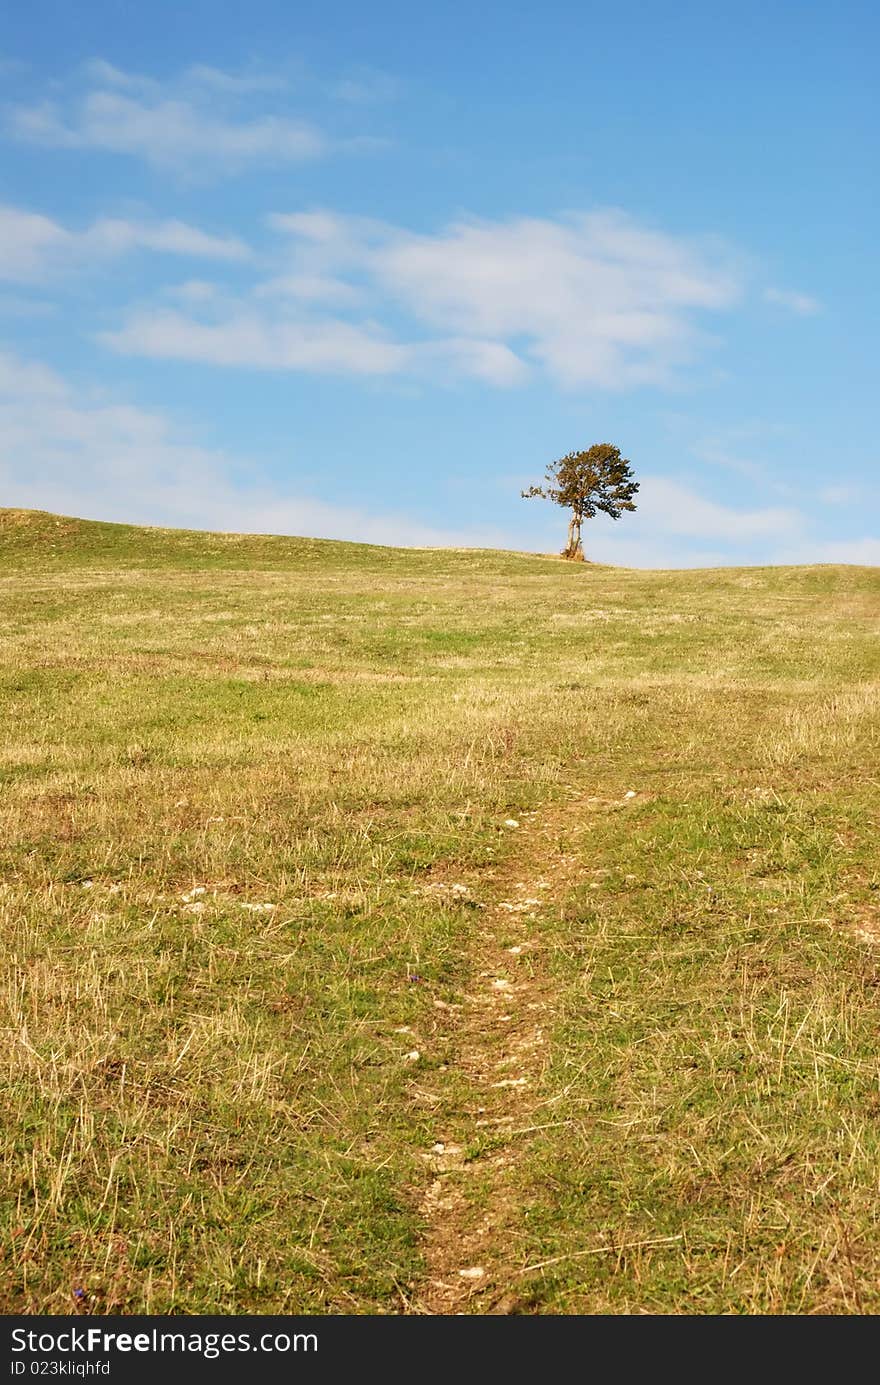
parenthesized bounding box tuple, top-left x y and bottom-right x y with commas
(412, 798, 606, 1314)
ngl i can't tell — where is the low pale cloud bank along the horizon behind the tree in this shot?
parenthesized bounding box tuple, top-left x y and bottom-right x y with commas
(0, 352, 880, 568)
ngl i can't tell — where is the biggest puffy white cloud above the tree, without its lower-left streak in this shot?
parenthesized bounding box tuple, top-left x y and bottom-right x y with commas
(274, 211, 740, 389)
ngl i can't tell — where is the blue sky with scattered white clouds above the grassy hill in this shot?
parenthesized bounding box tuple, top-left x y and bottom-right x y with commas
(0, 0, 880, 566)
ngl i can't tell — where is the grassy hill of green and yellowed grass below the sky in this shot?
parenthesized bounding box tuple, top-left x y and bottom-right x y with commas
(0, 511, 880, 1313)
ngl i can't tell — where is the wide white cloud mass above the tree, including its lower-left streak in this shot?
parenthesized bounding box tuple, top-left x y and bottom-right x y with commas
(104, 211, 740, 389)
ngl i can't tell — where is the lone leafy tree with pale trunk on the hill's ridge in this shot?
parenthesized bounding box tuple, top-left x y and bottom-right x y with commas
(522, 442, 639, 562)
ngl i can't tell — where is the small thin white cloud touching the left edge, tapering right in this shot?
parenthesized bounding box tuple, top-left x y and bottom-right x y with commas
(0, 205, 251, 283)
